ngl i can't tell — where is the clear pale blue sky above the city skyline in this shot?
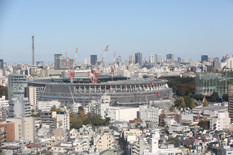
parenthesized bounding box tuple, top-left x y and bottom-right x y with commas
(0, 0, 233, 63)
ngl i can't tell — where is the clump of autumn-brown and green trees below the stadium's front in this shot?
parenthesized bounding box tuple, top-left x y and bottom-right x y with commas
(70, 107, 110, 129)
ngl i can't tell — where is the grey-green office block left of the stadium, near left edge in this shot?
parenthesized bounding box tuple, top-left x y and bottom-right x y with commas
(8, 74, 27, 100)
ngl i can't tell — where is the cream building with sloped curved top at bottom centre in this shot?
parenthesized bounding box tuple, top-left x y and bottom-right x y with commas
(96, 132, 114, 152)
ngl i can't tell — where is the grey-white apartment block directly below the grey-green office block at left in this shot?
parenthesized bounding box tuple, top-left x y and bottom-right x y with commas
(8, 98, 31, 118)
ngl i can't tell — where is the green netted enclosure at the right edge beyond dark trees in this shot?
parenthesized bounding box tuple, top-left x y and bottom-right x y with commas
(195, 72, 233, 96)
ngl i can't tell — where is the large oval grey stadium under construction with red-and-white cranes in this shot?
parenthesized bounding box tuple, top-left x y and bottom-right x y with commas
(28, 76, 172, 108)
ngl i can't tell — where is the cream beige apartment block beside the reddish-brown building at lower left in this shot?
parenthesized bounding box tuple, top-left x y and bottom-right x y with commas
(6, 117, 36, 143)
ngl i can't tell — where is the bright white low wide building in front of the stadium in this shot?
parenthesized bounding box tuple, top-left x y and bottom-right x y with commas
(105, 107, 139, 121)
